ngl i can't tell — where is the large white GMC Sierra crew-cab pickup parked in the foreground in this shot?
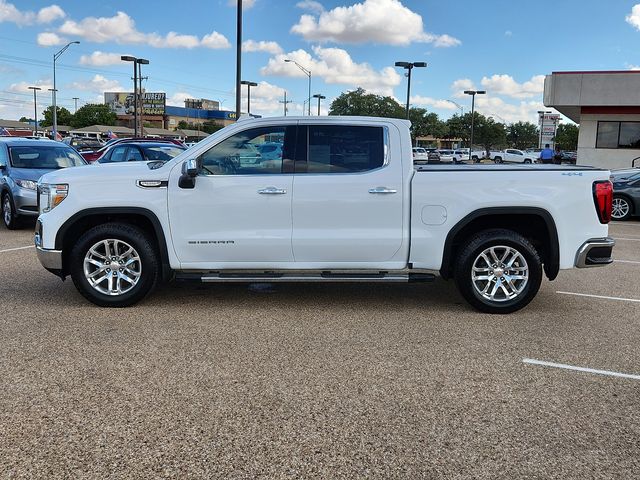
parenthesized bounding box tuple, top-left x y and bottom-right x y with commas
(35, 117, 614, 313)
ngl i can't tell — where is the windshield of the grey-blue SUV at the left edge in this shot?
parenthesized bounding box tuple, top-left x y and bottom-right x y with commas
(9, 144, 86, 170)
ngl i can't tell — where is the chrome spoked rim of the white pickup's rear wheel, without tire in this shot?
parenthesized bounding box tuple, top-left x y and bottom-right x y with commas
(471, 245, 529, 302)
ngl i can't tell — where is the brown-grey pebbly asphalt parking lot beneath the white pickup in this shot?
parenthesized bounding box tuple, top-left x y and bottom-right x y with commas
(0, 221, 640, 479)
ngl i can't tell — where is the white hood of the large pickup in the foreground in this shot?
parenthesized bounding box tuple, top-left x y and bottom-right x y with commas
(40, 162, 170, 184)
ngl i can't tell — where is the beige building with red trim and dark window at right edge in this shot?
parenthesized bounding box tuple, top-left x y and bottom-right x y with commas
(544, 70, 640, 169)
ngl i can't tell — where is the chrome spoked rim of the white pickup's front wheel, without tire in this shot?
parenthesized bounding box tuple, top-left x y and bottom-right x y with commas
(84, 238, 142, 296)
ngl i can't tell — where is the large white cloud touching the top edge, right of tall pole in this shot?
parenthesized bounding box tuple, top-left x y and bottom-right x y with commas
(291, 0, 460, 47)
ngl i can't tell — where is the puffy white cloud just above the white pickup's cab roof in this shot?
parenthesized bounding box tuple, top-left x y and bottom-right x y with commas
(260, 47, 402, 95)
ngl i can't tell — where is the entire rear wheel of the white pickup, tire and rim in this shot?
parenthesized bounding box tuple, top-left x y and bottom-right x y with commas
(455, 229, 542, 314)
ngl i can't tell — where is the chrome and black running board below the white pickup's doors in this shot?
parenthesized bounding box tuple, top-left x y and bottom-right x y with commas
(176, 272, 436, 283)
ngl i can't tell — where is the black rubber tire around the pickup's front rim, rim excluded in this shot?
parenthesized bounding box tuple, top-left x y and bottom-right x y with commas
(69, 223, 160, 307)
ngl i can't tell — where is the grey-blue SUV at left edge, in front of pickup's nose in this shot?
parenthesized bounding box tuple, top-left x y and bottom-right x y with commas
(0, 137, 87, 230)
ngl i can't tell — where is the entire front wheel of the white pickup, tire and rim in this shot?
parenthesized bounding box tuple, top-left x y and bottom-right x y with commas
(70, 223, 160, 307)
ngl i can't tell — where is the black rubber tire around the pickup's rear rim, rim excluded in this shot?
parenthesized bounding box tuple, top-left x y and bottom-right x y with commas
(454, 229, 542, 314)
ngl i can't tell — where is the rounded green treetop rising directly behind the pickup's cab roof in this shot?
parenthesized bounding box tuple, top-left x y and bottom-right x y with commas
(329, 88, 405, 118)
